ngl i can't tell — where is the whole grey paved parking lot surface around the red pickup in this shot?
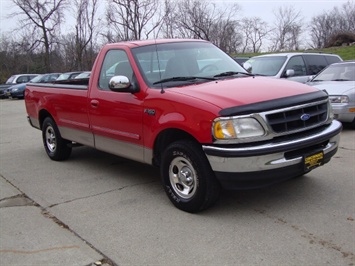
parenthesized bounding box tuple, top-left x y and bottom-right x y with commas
(0, 99, 355, 266)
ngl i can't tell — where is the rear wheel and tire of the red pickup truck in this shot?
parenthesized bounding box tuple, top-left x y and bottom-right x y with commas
(42, 117, 72, 161)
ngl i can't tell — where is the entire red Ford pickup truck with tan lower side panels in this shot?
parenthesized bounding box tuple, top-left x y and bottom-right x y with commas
(25, 39, 342, 212)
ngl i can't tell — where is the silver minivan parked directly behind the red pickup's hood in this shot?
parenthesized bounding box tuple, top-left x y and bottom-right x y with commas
(243, 53, 343, 83)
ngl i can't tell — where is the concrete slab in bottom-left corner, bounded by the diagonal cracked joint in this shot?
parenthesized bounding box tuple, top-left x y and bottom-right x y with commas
(0, 176, 111, 266)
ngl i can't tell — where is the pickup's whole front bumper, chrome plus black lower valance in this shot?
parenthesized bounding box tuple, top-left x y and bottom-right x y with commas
(203, 120, 342, 189)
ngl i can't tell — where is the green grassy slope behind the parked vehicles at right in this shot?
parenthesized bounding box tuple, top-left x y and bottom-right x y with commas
(235, 45, 355, 60)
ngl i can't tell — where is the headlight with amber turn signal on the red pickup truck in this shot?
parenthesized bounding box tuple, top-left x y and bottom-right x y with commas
(213, 117, 265, 140)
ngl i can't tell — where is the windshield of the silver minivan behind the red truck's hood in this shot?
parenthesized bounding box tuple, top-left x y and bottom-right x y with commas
(246, 56, 287, 76)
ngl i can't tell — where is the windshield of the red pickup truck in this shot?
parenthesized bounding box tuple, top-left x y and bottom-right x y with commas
(132, 42, 247, 88)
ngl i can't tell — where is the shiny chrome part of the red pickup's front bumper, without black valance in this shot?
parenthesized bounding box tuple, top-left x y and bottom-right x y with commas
(202, 120, 342, 175)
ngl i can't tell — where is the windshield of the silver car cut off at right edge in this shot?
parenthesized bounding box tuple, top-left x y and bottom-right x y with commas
(312, 63, 355, 81)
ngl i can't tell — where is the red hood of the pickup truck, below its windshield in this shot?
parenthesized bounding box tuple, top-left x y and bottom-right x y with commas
(169, 77, 319, 109)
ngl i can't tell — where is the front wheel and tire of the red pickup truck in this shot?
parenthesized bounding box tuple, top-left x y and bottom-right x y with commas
(160, 141, 221, 213)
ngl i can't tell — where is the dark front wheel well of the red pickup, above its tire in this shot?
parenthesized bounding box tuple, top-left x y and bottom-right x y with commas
(152, 129, 198, 166)
